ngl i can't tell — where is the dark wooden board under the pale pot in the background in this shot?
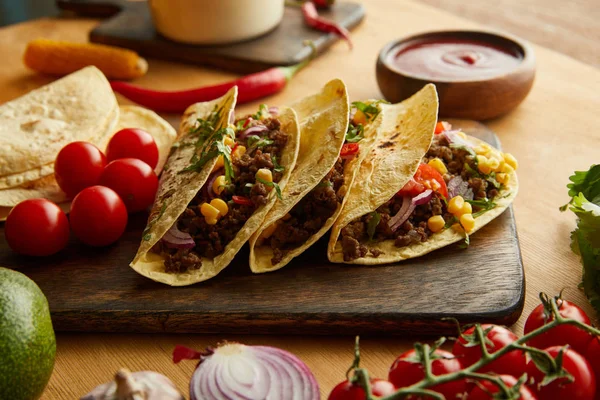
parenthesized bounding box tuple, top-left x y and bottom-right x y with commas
(56, 0, 365, 73)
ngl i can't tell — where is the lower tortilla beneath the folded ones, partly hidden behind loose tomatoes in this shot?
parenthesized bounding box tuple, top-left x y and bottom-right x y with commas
(0, 106, 177, 209)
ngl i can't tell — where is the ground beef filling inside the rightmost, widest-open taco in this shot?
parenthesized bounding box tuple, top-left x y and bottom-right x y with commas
(341, 135, 499, 261)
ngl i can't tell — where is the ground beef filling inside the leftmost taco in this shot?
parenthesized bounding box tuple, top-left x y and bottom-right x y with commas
(153, 118, 288, 273)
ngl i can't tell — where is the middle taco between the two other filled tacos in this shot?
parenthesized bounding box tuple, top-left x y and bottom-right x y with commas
(250, 79, 379, 273)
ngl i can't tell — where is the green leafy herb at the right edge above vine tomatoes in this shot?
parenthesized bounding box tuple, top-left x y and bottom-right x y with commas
(561, 165, 600, 312)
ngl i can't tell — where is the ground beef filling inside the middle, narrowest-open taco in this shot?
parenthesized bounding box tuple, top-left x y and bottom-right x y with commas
(262, 158, 344, 265)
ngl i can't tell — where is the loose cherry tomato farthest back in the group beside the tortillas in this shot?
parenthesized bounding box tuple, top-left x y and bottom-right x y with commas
(106, 128, 158, 169)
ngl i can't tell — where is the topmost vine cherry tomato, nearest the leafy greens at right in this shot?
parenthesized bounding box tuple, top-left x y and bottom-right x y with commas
(525, 300, 592, 354)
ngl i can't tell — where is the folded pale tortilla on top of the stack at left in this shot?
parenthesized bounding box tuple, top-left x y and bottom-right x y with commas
(0, 67, 119, 189)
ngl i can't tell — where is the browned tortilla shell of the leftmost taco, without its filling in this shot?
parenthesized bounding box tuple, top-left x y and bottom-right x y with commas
(130, 87, 300, 286)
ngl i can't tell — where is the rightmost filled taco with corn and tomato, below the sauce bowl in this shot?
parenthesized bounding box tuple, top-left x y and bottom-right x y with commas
(328, 85, 518, 264)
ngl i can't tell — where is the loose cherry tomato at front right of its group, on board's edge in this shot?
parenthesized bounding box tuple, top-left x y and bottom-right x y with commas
(71, 186, 127, 246)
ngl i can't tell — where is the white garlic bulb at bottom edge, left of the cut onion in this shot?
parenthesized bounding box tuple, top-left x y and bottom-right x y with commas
(80, 368, 185, 400)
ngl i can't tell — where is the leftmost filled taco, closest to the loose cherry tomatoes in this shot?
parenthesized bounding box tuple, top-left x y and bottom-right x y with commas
(131, 88, 300, 286)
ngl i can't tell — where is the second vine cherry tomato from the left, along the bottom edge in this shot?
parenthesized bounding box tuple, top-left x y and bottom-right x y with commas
(388, 349, 467, 399)
